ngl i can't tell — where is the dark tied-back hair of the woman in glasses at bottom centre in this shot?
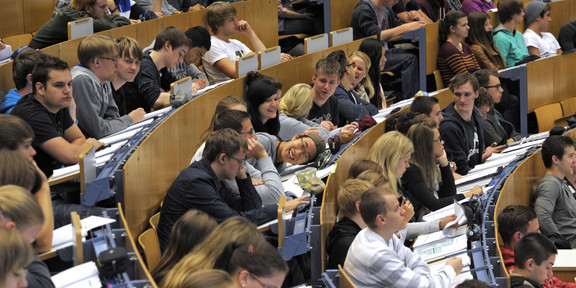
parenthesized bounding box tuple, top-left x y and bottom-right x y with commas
(214, 241, 288, 277)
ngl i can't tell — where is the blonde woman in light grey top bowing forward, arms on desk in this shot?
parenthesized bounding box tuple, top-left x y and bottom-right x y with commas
(278, 83, 354, 141)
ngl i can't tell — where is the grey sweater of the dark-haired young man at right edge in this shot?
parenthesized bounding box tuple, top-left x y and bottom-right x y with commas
(534, 174, 576, 248)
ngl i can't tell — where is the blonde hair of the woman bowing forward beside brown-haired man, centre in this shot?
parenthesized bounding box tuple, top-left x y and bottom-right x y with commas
(278, 83, 312, 119)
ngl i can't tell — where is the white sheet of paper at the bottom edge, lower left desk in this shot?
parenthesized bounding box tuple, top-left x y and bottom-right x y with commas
(52, 261, 102, 288)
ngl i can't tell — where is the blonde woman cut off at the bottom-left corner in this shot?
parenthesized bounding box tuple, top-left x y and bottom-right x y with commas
(0, 228, 34, 288)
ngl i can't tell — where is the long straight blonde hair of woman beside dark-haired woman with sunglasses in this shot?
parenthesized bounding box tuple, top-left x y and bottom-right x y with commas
(368, 131, 414, 196)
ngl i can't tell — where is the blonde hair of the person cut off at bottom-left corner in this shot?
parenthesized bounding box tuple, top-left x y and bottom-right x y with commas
(0, 227, 34, 287)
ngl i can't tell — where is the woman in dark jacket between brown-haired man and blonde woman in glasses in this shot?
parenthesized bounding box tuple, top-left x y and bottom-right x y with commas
(327, 50, 378, 127)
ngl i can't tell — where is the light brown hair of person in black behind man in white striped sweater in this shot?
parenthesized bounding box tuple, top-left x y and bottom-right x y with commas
(337, 179, 374, 219)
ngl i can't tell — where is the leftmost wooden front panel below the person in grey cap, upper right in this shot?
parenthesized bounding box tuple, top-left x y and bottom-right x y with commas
(526, 57, 555, 113)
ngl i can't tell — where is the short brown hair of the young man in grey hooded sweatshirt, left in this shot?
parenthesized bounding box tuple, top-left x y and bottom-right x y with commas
(78, 35, 118, 69)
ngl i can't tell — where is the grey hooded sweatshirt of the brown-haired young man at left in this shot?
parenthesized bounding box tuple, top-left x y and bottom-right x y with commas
(72, 66, 132, 139)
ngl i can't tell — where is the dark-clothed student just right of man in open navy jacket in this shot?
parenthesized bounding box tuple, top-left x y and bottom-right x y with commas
(474, 84, 522, 146)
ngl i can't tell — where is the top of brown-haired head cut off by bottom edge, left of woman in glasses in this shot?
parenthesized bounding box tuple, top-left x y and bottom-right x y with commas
(162, 269, 236, 288)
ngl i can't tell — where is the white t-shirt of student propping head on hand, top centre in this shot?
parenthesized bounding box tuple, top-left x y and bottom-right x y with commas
(202, 36, 252, 84)
